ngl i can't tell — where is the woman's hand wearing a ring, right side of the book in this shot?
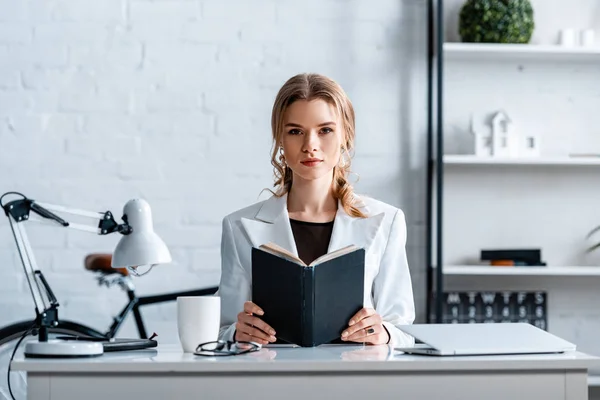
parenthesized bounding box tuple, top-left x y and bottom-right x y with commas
(342, 308, 390, 344)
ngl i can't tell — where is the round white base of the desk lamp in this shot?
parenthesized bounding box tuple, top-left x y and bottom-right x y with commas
(25, 340, 104, 358)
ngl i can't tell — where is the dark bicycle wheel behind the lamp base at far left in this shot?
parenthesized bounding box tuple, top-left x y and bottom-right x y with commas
(0, 321, 104, 400)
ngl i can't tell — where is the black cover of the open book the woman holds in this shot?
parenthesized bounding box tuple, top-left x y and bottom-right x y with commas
(252, 248, 365, 347)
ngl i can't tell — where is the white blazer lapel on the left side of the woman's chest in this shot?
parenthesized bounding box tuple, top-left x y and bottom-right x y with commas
(241, 194, 298, 256)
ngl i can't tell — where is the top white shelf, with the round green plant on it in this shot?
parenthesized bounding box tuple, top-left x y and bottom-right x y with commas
(444, 43, 600, 61)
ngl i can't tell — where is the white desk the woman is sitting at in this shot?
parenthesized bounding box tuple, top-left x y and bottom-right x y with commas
(12, 345, 599, 400)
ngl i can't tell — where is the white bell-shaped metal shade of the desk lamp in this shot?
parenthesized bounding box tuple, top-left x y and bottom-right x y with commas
(112, 199, 171, 269)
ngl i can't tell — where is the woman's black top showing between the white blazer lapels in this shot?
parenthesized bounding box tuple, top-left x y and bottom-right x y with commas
(290, 218, 333, 265)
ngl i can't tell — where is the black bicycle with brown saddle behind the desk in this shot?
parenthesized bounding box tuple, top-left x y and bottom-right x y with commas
(0, 253, 218, 399)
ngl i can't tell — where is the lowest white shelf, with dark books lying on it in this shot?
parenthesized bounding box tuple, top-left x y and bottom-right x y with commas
(444, 265, 600, 277)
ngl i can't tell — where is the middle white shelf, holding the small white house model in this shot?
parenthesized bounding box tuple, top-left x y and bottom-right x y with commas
(444, 155, 600, 166)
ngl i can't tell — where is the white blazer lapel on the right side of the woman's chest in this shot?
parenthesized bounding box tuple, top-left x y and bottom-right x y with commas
(327, 199, 385, 253)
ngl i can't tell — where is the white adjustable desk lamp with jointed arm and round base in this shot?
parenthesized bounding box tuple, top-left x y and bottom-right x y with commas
(0, 192, 171, 358)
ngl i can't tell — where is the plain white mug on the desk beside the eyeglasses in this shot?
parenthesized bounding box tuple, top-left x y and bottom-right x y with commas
(177, 296, 221, 353)
